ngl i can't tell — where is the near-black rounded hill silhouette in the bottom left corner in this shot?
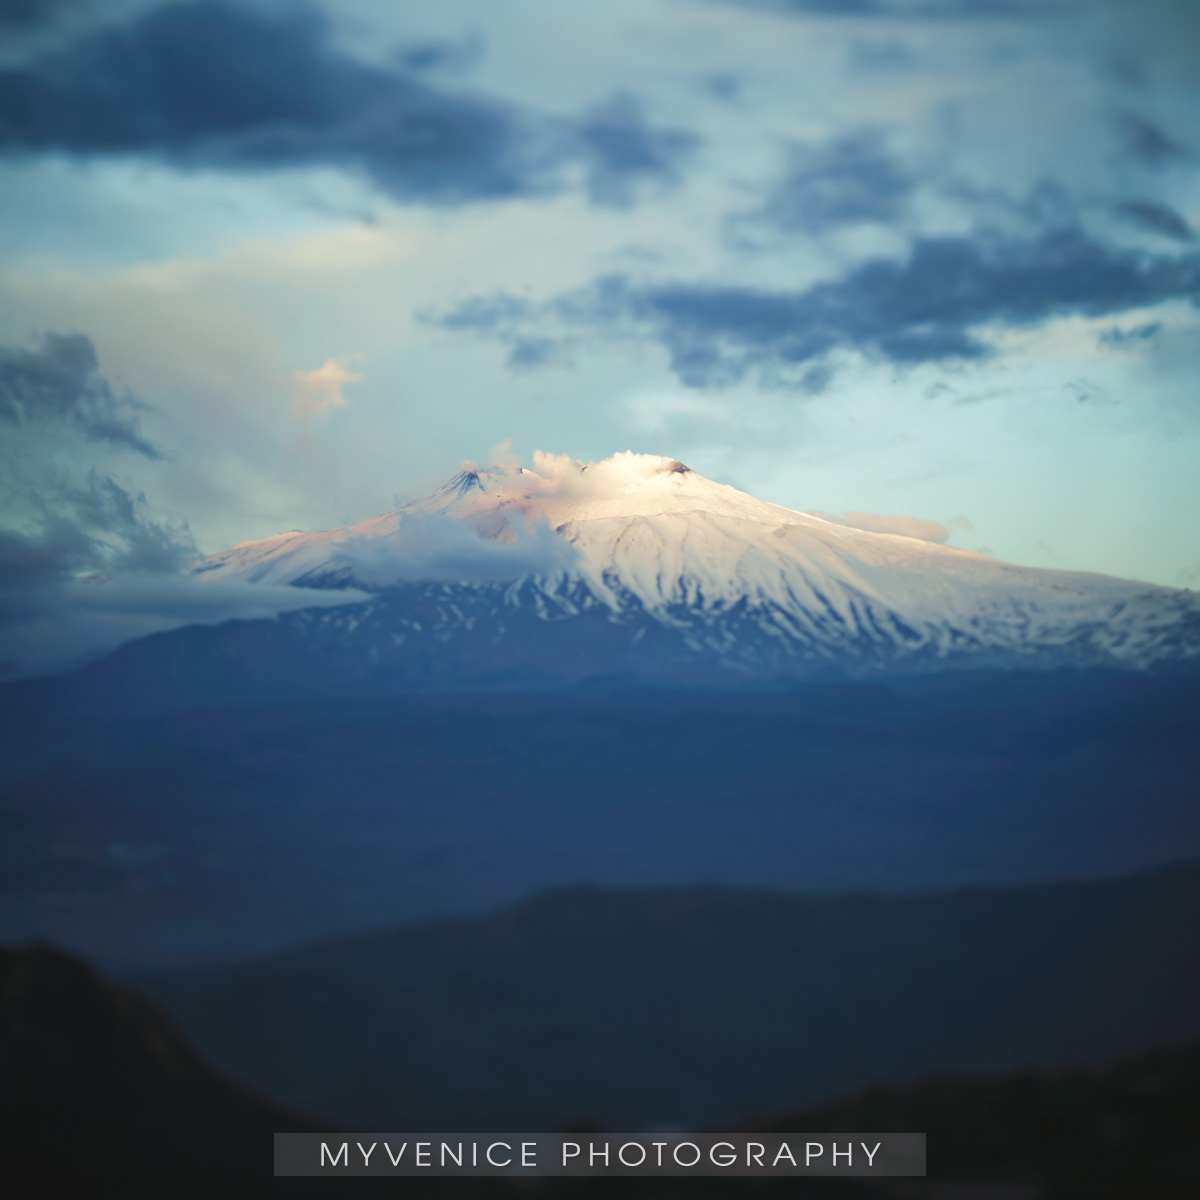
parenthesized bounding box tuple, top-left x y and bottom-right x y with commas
(0, 946, 316, 1198)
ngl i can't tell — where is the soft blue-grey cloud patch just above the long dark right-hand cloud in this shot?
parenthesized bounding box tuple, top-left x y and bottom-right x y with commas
(748, 132, 913, 233)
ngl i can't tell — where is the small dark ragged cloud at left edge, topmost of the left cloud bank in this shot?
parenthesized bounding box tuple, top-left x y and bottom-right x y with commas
(0, 334, 161, 458)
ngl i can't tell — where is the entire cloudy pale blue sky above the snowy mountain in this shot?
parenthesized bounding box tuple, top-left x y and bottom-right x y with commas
(0, 0, 1200, 670)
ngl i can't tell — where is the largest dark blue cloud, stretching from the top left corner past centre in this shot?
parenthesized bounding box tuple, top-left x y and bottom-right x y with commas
(0, 0, 694, 205)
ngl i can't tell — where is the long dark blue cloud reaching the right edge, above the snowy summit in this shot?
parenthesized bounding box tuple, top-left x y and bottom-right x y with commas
(439, 228, 1200, 388)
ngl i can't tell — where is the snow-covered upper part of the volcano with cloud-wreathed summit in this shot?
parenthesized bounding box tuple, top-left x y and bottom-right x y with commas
(194, 452, 1200, 676)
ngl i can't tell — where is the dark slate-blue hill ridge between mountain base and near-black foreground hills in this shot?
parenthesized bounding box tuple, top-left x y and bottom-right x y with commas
(140, 864, 1200, 1129)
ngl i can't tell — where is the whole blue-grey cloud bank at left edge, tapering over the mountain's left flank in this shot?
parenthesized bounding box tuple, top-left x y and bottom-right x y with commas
(0, 324, 364, 678)
